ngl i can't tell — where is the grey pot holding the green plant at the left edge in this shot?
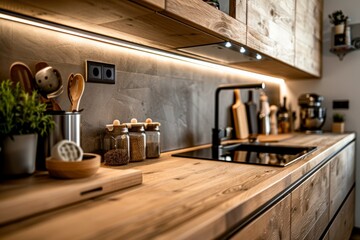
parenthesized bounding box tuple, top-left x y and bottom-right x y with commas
(0, 134, 38, 178)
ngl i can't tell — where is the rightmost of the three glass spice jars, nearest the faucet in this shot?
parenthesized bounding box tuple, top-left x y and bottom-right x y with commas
(145, 118, 160, 158)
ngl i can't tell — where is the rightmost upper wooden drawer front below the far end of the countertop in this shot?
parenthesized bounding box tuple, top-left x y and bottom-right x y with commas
(330, 143, 355, 218)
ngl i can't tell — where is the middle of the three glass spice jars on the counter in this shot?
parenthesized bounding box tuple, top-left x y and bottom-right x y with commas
(128, 118, 146, 162)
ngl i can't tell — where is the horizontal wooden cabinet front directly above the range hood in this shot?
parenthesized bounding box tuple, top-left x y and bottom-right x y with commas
(165, 0, 246, 44)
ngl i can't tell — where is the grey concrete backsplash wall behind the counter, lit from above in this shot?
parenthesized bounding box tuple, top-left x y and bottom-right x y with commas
(0, 20, 280, 152)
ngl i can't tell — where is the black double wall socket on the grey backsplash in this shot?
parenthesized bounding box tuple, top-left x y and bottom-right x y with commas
(85, 60, 115, 84)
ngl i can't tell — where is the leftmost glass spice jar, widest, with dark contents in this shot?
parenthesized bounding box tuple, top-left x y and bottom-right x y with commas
(104, 120, 130, 166)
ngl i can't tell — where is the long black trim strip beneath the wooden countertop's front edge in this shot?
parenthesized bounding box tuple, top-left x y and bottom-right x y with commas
(216, 140, 355, 239)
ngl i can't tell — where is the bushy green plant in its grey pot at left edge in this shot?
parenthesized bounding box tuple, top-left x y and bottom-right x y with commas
(0, 80, 54, 177)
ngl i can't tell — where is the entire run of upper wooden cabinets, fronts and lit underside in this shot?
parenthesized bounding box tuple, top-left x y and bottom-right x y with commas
(0, 0, 322, 79)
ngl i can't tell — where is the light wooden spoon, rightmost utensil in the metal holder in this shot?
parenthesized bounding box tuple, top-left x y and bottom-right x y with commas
(68, 73, 85, 112)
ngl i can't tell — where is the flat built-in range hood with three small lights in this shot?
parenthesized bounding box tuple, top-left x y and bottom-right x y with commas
(177, 42, 264, 64)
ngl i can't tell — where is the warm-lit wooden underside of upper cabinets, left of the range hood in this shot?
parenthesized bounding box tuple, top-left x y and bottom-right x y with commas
(0, 0, 222, 49)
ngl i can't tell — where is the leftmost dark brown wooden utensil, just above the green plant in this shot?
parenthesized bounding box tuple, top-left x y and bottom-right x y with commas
(10, 62, 34, 93)
